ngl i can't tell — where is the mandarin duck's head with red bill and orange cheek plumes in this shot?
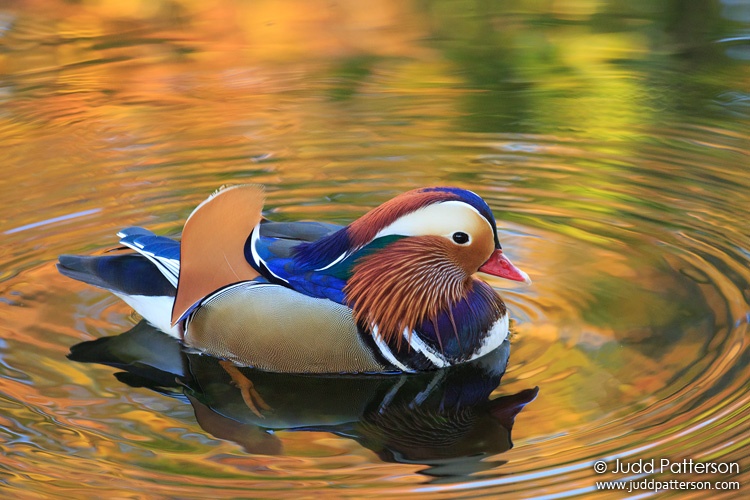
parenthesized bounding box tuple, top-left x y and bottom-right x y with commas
(320, 187, 529, 348)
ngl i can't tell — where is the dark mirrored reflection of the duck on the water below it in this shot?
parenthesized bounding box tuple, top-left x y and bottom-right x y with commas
(70, 322, 537, 476)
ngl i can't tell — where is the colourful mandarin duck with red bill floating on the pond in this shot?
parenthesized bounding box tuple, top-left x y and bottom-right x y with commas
(58, 185, 530, 373)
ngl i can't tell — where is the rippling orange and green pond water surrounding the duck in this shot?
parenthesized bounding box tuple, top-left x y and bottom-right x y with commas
(0, 0, 750, 498)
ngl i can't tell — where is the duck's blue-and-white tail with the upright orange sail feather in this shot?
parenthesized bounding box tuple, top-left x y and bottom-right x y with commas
(57, 185, 264, 336)
